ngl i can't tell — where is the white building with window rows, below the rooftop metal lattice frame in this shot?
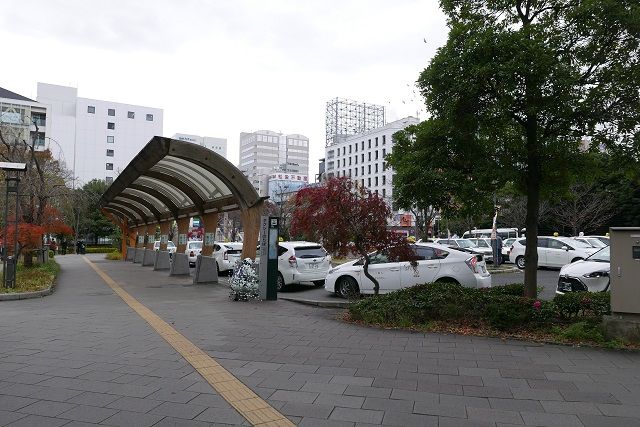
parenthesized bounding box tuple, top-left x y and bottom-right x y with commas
(324, 117, 420, 205)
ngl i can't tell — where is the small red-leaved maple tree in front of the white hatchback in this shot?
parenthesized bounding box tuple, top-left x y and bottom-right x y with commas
(290, 177, 415, 295)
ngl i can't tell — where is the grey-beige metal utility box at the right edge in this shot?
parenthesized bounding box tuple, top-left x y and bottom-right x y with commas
(609, 227, 640, 314)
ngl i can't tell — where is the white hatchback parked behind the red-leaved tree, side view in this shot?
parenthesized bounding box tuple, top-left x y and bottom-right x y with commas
(324, 243, 491, 297)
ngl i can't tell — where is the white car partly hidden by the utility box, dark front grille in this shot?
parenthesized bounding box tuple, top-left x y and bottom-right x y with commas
(556, 246, 611, 294)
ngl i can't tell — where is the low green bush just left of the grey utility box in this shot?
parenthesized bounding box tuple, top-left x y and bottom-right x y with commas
(553, 292, 611, 319)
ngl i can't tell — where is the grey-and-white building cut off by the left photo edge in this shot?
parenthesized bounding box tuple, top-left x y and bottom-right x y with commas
(0, 87, 48, 150)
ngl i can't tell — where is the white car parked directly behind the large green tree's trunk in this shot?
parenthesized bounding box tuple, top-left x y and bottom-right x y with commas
(509, 236, 598, 269)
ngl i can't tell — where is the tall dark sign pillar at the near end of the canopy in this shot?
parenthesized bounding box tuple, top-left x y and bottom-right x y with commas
(259, 216, 280, 300)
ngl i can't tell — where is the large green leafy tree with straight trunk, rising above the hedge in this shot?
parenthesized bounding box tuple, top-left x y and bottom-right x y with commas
(418, 0, 640, 296)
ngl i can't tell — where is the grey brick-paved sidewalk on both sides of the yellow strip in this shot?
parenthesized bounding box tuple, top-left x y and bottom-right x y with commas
(0, 256, 640, 427)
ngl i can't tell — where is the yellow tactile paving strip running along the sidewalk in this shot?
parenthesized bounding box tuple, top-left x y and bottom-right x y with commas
(83, 257, 294, 426)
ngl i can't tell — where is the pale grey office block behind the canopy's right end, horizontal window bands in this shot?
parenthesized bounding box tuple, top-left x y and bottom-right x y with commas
(238, 130, 309, 196)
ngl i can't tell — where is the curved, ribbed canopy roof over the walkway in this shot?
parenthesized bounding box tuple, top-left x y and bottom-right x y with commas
(100, 136, 262, 226)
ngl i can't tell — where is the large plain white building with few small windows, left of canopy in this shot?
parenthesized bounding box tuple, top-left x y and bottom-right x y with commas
(37, 83, 163, 186)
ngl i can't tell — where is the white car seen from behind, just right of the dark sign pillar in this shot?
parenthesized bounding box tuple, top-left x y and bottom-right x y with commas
(277, 242, 331, 291)
